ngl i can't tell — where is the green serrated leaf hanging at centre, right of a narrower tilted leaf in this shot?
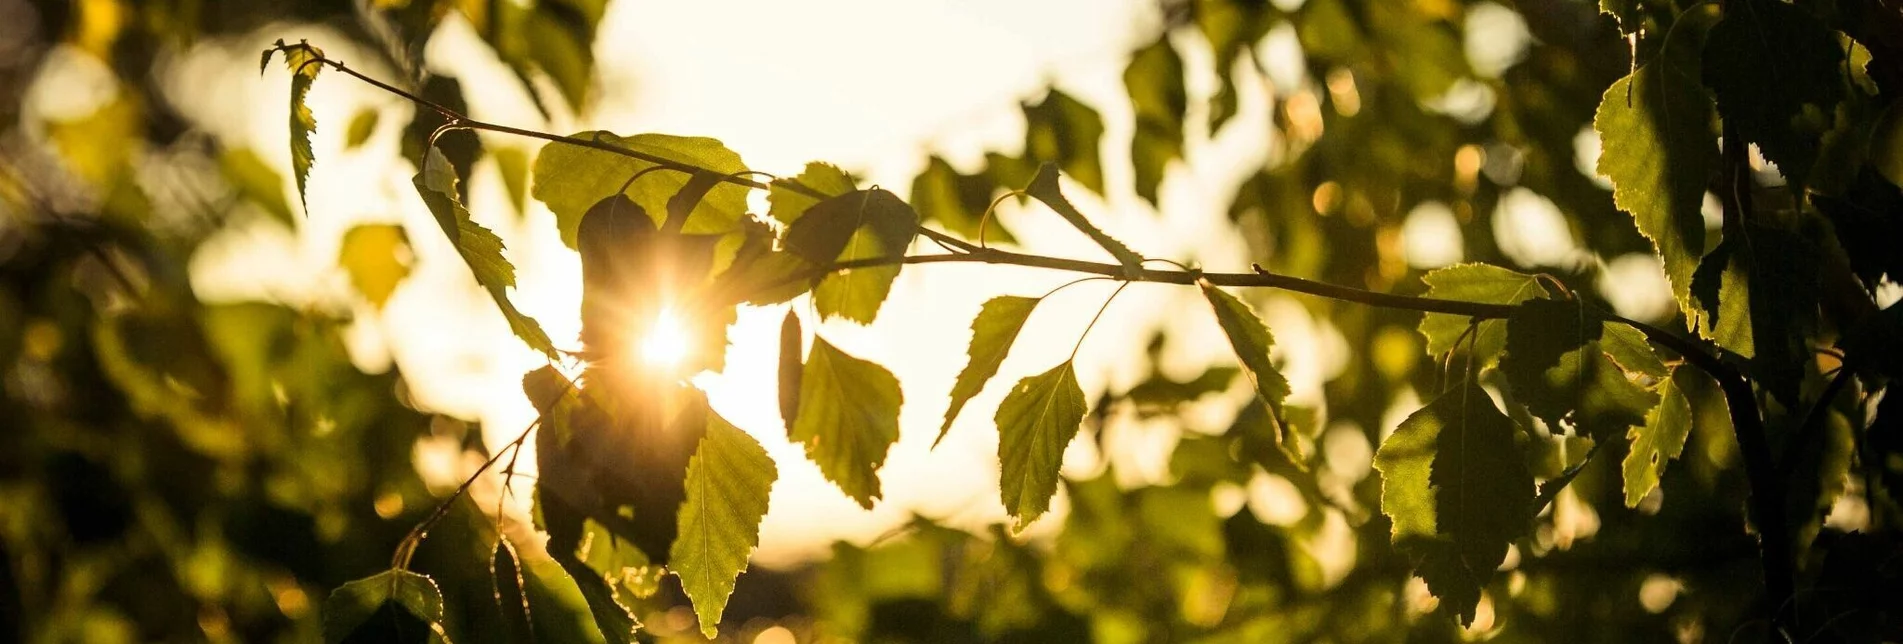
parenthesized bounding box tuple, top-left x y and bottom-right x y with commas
(997, 360, 1085, 530)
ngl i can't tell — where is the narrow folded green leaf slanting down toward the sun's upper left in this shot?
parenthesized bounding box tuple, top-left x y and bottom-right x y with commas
(411, 149, 561, 360)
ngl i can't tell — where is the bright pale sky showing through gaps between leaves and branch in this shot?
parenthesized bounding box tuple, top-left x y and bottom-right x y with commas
(152, 0, 1658, 566)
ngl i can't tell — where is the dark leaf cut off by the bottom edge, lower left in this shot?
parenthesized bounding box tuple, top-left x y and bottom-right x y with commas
(324, 570, 449, 644)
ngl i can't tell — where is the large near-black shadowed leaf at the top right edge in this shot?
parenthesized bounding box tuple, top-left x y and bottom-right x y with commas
(1703, 0, 1846, 187)
